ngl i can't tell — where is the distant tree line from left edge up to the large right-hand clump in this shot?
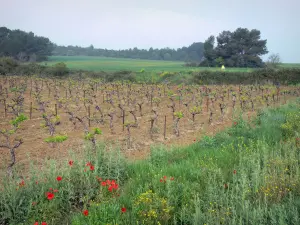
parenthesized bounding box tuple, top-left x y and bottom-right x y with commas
(0, 27, 204, 62)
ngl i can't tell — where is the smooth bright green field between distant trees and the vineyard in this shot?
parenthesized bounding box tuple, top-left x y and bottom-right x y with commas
(43, 56, 252, 72)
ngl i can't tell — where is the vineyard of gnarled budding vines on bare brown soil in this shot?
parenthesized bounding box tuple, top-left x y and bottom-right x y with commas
(0, 77, 299, 178)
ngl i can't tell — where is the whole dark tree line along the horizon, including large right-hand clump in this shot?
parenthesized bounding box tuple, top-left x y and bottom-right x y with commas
(0, 27, 268, 67)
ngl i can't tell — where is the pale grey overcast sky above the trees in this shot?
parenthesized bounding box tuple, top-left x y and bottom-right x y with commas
(0, 0, 300, 63)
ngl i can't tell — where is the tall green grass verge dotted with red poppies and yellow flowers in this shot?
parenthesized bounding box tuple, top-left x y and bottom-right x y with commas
(0, 103, 300, 225)
